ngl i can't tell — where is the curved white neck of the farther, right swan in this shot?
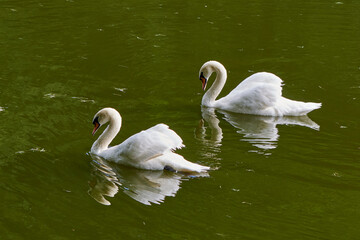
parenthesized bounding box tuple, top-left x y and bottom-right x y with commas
(202, 66, 227, 107)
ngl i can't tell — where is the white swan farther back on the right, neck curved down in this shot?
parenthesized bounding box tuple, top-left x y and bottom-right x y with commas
(199, 61, 321, 116)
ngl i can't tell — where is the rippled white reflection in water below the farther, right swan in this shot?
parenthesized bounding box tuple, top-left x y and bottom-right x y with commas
(197, 107, 320, 153)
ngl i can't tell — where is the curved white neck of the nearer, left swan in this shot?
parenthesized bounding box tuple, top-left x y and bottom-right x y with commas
(91, 116, 121, 154)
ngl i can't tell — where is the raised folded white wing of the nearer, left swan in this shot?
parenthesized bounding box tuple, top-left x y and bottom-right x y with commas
(116, 123, 184, 163)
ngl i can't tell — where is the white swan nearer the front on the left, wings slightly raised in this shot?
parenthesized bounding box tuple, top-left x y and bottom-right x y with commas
(91, 108, 210, 172)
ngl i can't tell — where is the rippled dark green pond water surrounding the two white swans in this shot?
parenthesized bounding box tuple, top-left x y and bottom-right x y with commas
(0, 0, 360, 240)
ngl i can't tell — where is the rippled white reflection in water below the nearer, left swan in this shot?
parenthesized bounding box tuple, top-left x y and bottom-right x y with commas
(88, 155, 209, 205)
